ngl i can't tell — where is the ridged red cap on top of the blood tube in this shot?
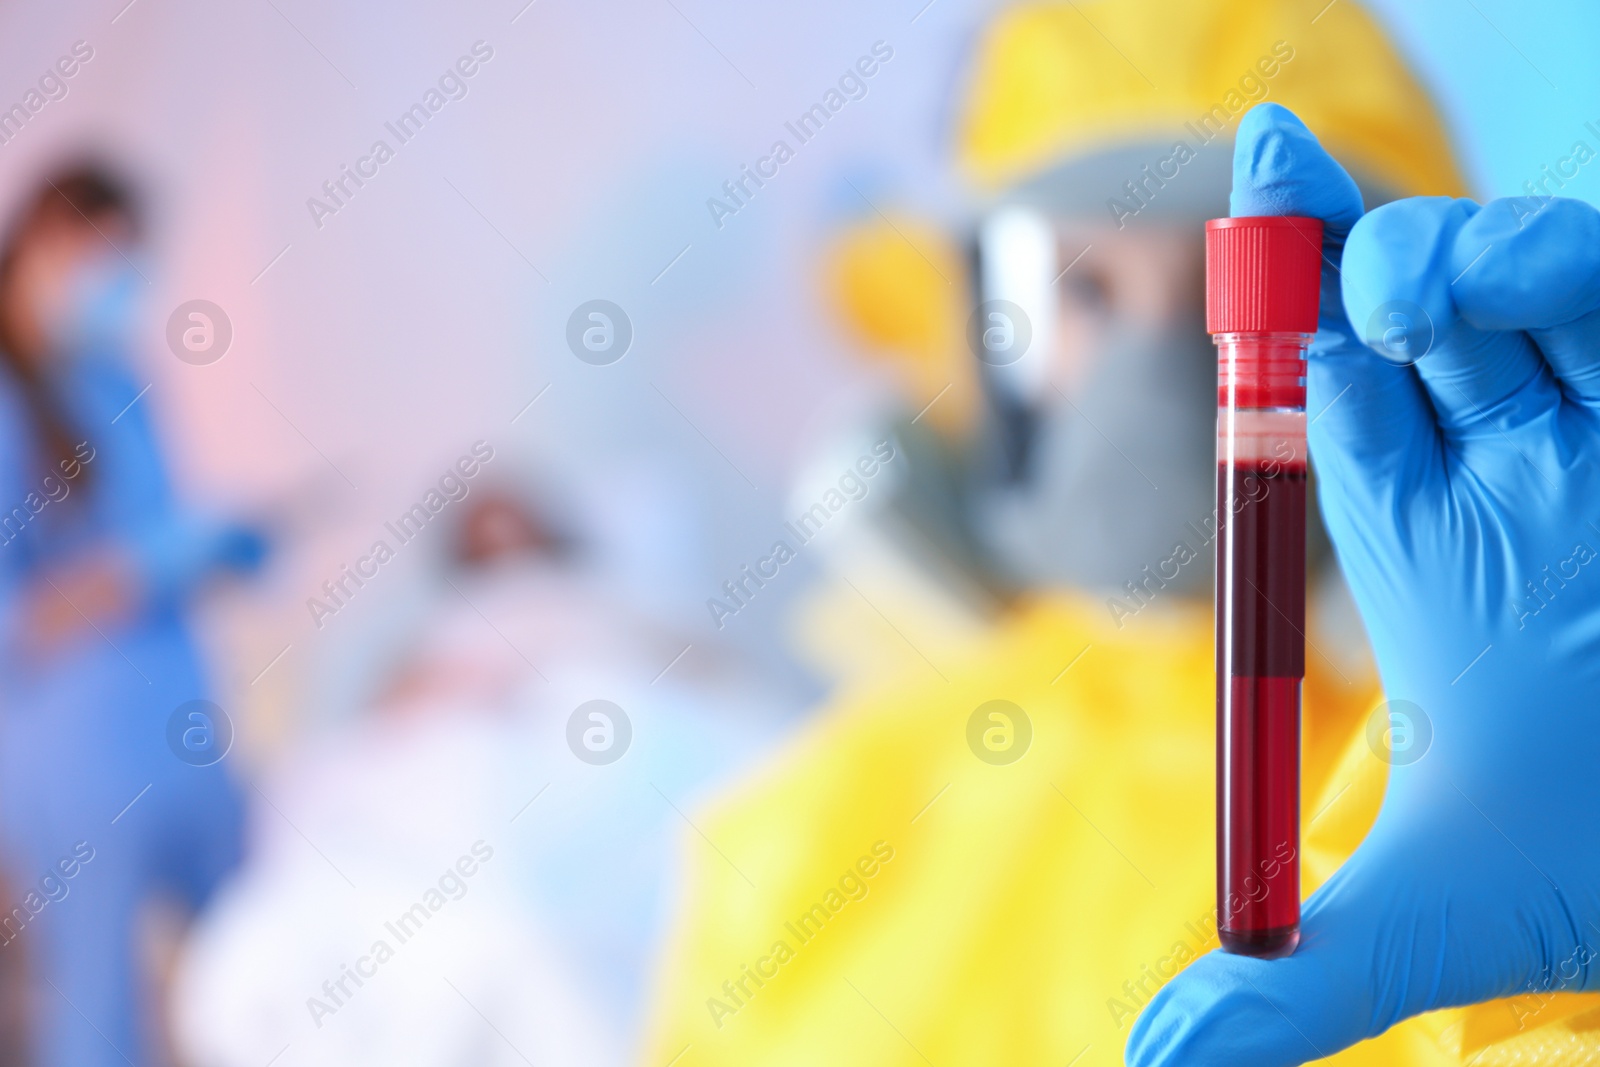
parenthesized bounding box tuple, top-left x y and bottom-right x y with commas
(1205, 214, 1322, 333)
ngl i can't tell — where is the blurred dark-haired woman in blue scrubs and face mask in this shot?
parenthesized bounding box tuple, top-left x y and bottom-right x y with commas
(0, 165, 264, 1067)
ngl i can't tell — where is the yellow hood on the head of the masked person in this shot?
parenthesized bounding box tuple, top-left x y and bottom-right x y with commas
(957, 0, 1464, 195)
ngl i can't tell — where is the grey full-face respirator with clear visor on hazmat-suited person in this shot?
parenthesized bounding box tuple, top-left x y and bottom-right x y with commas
(968, 144, 1230, 595)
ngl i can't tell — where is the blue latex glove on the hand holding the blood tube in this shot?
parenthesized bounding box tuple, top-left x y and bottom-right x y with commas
(1128, 104, 1600, 1067)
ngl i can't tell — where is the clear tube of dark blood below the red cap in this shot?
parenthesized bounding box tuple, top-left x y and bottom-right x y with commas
(1214, 331, 1310, 958)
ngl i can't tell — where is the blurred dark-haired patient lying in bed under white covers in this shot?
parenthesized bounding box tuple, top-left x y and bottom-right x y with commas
(176, 485, 782, 1067)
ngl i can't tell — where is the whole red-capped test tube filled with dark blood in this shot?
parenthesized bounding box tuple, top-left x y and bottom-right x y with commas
(1206, 216, 1322, 958)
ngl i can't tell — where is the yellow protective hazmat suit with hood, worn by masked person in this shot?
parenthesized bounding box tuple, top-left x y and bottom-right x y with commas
(643, 0, 1600, 1067)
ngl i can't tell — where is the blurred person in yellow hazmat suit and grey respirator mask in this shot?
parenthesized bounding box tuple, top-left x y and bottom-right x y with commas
(650, 0, 1600, 1067)
